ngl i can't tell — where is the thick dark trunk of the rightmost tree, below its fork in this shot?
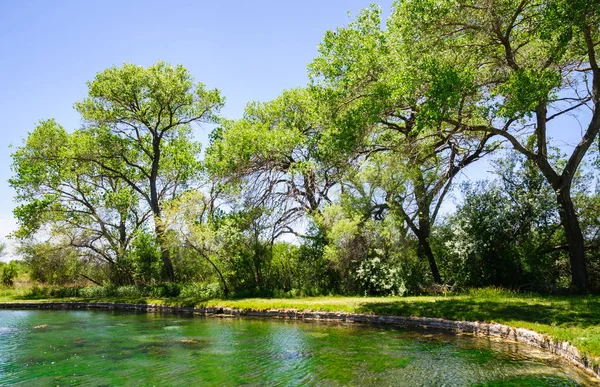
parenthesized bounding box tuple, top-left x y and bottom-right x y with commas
(555, 188, 589, 293)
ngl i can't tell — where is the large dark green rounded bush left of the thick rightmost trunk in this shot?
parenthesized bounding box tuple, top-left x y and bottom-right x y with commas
(436, 166, 568, 291)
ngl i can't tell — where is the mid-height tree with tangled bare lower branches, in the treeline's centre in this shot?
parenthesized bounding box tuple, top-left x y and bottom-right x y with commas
(207, 89, 337, 242)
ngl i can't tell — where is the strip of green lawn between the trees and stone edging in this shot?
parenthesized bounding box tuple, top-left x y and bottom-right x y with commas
(0, 289, 600, 364)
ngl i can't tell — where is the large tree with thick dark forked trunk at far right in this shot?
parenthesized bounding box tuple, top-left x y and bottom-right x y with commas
(388, 0, 600, 291)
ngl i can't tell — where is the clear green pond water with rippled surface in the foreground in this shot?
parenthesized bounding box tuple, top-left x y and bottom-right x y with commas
(0, 310, 595, 387)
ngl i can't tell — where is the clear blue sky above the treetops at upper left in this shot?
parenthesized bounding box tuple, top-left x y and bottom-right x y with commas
(0, 0, 592, 260)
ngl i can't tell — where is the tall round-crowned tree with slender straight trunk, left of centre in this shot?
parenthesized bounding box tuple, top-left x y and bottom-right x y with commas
(75, 62, 224, 281)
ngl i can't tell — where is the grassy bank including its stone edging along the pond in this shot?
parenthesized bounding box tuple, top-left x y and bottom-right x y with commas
(0, 289, 600, 375)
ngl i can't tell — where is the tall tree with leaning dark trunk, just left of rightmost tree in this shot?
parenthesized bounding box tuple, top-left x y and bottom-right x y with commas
(310, 6, 494, 283)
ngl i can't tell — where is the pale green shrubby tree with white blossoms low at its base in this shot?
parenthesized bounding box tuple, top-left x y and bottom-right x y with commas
(317, 162, 420, 295)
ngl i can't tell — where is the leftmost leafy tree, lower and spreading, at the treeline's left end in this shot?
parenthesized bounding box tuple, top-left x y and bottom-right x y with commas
(10, 120, 150, 283)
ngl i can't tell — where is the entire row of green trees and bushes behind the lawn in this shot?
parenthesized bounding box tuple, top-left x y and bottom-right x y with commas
(10, 0, 600, 296)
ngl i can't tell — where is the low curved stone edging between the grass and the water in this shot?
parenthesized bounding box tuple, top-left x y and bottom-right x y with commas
(0, 302, 600, 378)
